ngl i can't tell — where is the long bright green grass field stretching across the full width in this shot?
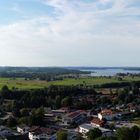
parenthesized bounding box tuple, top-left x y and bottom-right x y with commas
(0, 77, 140, 89)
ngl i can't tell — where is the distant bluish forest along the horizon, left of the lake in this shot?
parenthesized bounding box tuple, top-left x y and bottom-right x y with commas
(0, 67, 89, 81)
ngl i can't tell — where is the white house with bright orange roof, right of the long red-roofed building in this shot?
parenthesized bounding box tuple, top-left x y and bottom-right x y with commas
(98, 109, 118, 121)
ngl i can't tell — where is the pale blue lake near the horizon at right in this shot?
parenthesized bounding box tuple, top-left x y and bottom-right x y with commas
(81, 69, 140, 76)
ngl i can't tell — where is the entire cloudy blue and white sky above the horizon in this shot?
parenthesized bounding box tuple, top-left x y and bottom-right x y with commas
(0, 0, 140, 66)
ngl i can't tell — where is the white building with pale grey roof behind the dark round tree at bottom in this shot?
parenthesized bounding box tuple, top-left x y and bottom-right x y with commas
(78, 123, 112, 137)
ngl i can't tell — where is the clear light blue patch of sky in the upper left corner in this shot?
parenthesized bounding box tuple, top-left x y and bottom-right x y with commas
(0, 0, 53, 24)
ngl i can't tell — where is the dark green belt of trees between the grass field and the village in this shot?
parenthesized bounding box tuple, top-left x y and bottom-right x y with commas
(0, 86, 96, 109)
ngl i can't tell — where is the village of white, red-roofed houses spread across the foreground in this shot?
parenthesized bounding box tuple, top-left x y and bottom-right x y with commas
(0, 84, 140, 140)
